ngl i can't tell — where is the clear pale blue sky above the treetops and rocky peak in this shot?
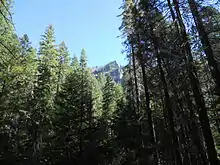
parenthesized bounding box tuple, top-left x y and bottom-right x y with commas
(13, 0, 126, 66)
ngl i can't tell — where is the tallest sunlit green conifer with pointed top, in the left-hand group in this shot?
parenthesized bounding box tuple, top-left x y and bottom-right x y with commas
(28, 25, 58, 162)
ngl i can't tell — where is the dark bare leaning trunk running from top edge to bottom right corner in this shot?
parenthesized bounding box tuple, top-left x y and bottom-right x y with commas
(173, 0, 218, 165)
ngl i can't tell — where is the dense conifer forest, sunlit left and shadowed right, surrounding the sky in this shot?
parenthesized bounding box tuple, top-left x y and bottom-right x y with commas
(0, 0, 220, 165)
